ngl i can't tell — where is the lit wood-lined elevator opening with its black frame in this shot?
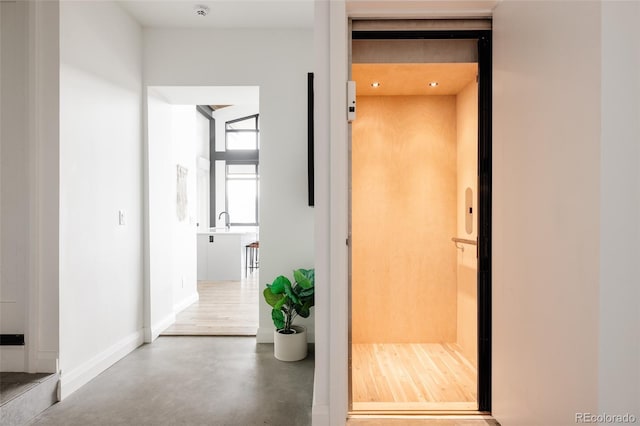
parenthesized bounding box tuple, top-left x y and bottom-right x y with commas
(349, 21, 491, 413)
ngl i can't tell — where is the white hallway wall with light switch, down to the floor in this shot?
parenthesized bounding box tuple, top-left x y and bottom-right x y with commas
(60, 2, 143, 398)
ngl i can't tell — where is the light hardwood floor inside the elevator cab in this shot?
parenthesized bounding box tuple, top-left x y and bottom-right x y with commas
(352, 343, 478, 412)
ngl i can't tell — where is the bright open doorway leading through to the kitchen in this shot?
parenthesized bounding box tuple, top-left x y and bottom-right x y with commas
(147, 86, 259, 340)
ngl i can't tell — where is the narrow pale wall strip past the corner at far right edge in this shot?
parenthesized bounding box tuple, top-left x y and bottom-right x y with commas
(598, 1, 640, 419)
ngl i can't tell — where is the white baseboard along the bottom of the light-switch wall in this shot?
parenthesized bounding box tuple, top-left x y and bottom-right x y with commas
(60, 330, 144, 400)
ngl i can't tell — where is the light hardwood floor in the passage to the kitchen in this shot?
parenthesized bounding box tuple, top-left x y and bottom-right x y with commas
(161, 271, 259, 336)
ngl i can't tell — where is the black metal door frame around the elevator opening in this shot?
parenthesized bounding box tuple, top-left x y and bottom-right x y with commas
(348, 26, 492, 413)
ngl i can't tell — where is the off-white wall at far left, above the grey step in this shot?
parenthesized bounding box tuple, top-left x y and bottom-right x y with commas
(0, 1, 59, 372)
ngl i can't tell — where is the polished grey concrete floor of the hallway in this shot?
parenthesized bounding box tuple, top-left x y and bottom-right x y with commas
(30, 337, 314, 426)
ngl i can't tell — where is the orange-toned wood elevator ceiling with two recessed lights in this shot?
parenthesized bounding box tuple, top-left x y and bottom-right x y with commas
(351, 63, 478, 96)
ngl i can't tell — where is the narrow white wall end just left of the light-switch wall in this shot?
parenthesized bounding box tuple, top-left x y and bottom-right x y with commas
(27, 0, 60, 372)
